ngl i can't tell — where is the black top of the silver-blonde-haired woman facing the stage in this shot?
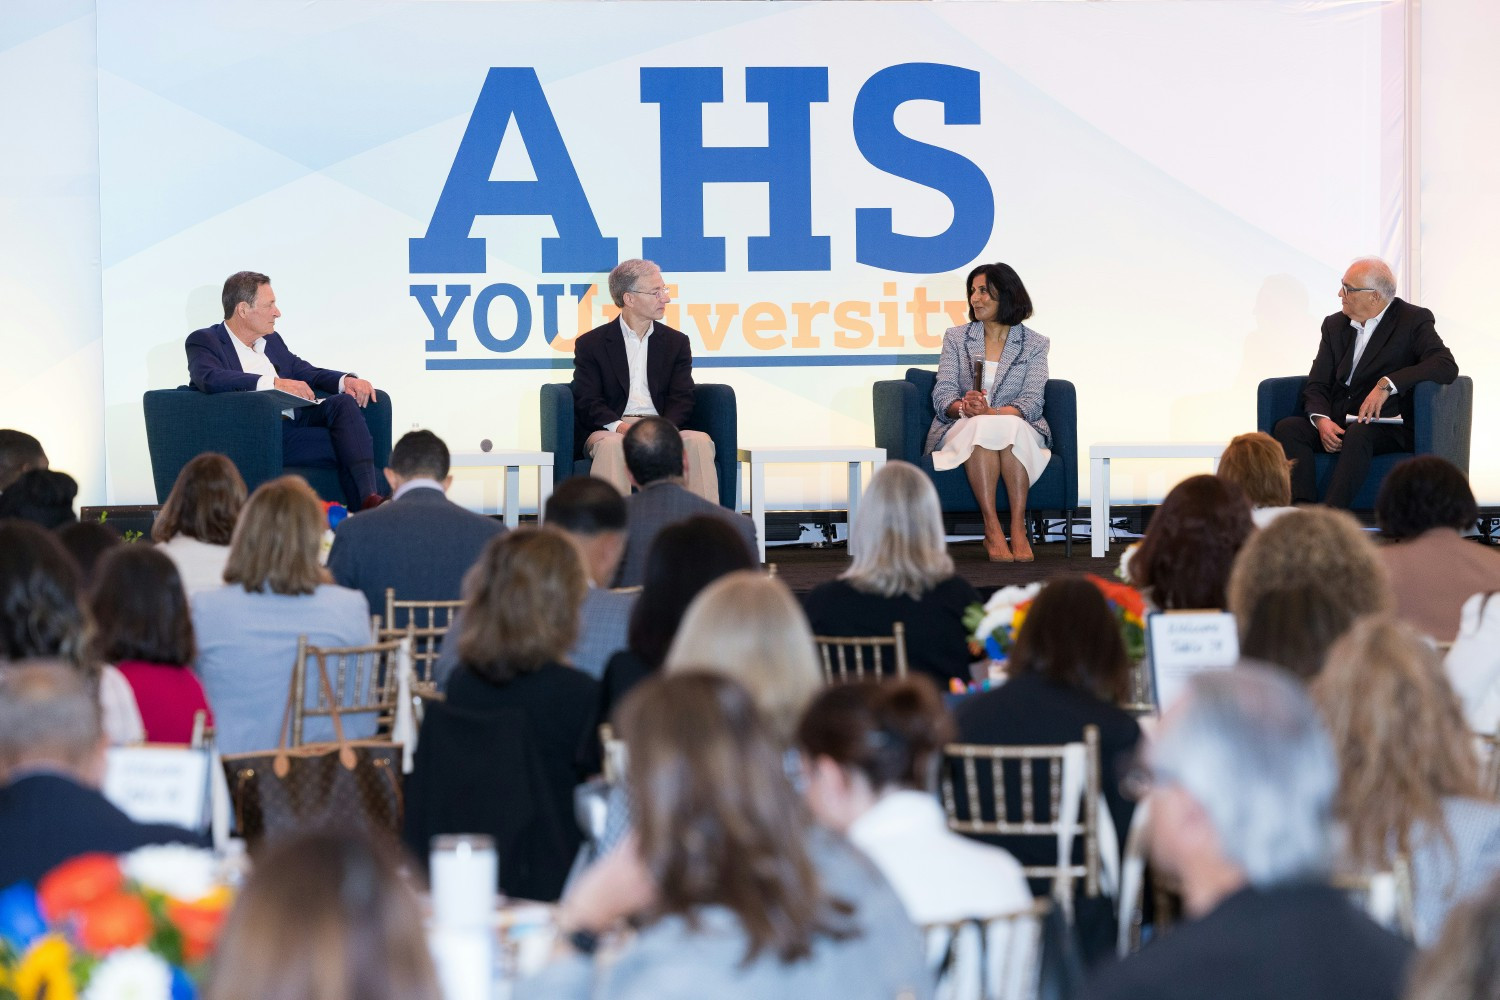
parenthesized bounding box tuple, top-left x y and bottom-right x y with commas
(803, 576, 980, 691)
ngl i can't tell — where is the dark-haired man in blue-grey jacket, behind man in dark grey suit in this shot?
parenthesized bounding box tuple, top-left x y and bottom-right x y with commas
(542, 475, 639, 678)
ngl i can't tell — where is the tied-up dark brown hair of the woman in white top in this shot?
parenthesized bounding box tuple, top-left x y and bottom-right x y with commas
(797, 675, 954, 793)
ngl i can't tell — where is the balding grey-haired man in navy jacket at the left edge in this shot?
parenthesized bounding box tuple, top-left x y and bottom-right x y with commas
(0, 660, 203, 886)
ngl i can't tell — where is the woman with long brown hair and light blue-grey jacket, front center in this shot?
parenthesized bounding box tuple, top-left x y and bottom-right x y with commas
(516, 672, 932, 1000)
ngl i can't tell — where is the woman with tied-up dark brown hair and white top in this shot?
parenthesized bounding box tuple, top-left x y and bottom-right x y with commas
(797, 676, 1032, 924)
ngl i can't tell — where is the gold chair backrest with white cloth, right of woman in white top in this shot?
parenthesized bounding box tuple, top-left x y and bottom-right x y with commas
(941, 726, 1101, 915)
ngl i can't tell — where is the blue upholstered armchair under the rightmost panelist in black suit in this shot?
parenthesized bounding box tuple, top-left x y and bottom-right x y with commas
(1256, 375, 1475, 510)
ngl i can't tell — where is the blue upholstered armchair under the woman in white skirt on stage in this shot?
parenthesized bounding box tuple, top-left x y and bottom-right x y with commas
(875, 367, 1079, 556)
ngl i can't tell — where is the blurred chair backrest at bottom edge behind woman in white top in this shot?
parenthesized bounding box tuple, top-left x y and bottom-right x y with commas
(920, 900, 1052, 1000)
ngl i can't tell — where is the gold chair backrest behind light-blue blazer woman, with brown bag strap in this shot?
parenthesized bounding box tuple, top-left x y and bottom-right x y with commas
(288, 636, 402, 747)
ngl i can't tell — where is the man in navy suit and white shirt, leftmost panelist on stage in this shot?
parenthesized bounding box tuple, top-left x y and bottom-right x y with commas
(186, 271, 381, 510)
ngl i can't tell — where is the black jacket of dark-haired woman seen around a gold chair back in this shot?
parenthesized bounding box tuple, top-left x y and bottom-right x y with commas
(954, 673, 1140, 889)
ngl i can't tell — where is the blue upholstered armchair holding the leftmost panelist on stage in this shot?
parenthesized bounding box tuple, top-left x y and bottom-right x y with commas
(141, 385, 390, 504)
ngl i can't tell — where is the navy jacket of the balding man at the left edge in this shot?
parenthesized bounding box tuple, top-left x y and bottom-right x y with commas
(0, 772, 207, 889)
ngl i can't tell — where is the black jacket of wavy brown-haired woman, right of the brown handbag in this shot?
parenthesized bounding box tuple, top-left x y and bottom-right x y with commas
(405, 663, 600, 901)
